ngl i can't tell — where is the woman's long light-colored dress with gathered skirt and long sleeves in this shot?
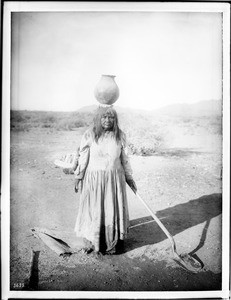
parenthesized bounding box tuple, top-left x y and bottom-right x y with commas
(75, 129, 132, 251)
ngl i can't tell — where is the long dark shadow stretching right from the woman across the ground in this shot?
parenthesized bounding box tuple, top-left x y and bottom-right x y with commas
(126, 193, 222, 252)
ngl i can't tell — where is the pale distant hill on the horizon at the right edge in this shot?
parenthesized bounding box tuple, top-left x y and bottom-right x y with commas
(153, 100, 222, 117)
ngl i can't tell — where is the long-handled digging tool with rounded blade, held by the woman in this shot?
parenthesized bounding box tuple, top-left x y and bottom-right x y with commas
(135, 192, 202, 273)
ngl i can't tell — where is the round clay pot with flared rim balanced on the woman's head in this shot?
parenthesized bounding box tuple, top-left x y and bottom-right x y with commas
(95, 75, 119, 105)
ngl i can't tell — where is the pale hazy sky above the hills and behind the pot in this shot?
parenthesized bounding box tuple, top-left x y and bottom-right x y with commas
(11, 12, 222, 111)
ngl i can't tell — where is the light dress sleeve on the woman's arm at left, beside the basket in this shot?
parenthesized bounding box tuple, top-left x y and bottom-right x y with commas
(74, 130, 92, 179)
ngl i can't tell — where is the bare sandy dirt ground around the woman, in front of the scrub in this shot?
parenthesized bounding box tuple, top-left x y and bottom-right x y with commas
(10, 130, 222, 291)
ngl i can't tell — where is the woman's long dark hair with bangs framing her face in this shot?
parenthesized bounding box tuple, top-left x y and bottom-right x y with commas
(93, 106, 121, 142)
